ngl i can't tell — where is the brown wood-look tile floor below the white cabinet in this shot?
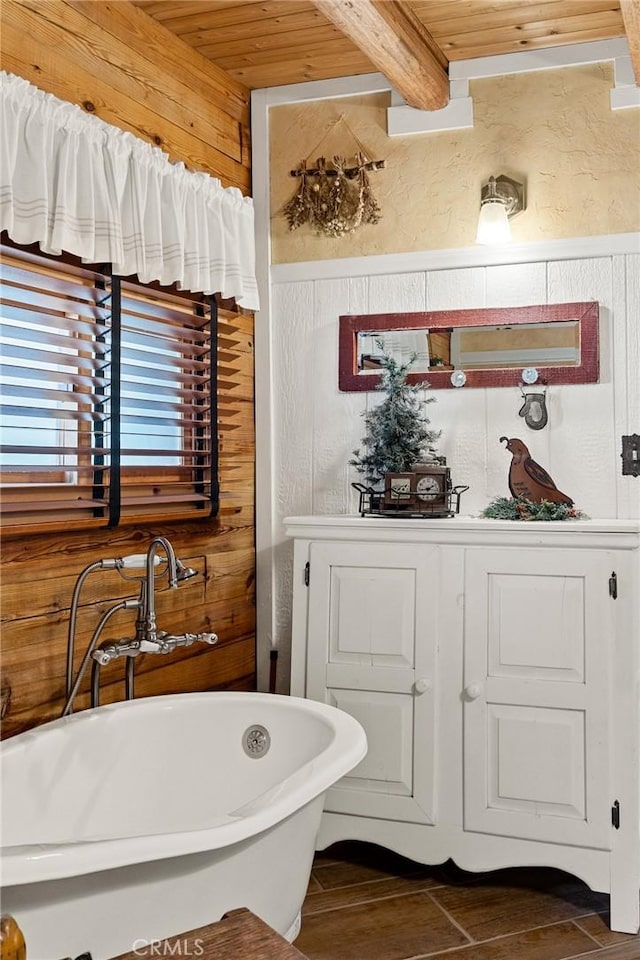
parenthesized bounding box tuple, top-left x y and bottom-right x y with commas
(295, 841, 640, 960)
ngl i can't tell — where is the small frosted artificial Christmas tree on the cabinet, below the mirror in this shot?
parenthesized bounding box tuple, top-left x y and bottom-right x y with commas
(349, 340, 440, 485)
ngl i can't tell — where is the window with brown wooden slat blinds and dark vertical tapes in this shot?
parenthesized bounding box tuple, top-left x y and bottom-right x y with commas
(0, 247, 218, 531)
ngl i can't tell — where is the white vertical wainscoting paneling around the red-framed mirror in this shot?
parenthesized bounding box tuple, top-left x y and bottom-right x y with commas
(256, 234, 640, 689)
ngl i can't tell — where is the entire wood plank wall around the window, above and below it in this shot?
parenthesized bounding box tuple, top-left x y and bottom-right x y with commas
(0, 0, 255, 737)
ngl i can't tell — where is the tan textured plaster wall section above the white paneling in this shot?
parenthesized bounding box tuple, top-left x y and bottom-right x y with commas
(269, 62, 640, 264)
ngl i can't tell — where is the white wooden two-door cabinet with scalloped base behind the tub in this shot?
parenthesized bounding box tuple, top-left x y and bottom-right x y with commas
(286, 517, 640, 932)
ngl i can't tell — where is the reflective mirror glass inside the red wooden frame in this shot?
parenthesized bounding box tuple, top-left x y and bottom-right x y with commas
(357, 319, 580, 376)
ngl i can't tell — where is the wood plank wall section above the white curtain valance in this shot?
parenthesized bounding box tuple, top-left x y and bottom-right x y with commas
(0, 0, 250, 193)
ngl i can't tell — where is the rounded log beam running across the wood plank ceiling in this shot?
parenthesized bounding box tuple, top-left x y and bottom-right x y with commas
(312, 0, 449, 110)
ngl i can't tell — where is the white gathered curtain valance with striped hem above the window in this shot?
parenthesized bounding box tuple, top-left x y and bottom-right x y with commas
(0, 71, 258, 310)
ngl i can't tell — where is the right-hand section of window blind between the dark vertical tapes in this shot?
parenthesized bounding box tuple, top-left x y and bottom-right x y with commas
(119, 281, 218, 518)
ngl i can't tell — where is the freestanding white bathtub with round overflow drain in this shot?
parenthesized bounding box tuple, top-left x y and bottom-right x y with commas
(0, 693, 366, 960)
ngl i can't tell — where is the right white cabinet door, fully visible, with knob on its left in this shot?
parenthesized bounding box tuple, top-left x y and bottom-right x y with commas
(464, 549, 613, 849)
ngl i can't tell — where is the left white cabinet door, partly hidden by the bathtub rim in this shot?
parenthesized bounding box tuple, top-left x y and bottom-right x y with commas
(307, 542, 439, 823)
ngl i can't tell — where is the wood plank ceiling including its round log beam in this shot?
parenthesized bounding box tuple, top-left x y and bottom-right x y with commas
(133, 0, 640, 109)
